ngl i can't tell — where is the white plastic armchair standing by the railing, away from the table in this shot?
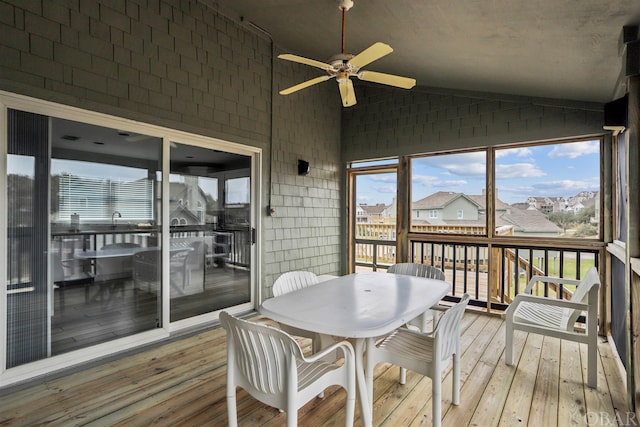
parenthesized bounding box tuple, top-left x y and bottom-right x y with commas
(502, 267, 600, 388)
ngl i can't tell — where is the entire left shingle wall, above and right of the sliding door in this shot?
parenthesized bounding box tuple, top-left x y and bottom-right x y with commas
(0, 0, 340, 294)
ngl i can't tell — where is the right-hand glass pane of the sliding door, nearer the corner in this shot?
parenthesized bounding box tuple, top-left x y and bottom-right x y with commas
(169, 142, 253, 322)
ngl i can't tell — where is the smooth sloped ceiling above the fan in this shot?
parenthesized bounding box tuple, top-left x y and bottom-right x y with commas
(214, 0, 640, 102)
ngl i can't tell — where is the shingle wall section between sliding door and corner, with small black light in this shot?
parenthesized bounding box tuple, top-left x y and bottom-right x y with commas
(263, 52, 343, 295)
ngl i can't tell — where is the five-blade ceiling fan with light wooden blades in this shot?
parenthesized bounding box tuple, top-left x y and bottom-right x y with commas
(278, 0, 416, 107)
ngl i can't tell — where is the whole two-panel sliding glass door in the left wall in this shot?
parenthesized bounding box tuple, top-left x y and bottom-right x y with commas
(0, 104, 255, 368)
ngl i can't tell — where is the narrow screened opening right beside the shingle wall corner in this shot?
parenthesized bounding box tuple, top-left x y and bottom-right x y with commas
(349, 168, 398, 272)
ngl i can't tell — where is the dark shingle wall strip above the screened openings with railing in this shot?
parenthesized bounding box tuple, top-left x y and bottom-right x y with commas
(342, 84, 603, 161)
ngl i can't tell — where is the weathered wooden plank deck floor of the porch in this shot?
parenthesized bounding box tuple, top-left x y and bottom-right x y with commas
(0, 312, 635, 427)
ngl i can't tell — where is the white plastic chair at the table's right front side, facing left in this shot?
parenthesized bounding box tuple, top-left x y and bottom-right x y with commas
(367, 294, 469, 427)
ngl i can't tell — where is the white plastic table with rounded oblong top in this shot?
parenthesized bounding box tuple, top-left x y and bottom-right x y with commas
(260, 272, 451, 426)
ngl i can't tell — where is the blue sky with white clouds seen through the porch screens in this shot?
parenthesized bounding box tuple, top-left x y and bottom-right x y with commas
(356, 140, 600, 205)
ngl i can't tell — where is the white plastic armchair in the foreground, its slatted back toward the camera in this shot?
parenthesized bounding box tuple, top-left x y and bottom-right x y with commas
(220, 311, 356, 427)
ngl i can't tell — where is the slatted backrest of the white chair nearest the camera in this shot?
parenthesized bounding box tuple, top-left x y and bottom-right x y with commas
(220, 311, 303, 394)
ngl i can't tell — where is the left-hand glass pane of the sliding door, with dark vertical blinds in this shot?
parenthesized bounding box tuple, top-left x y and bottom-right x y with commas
(6, 110, 162, 368)
